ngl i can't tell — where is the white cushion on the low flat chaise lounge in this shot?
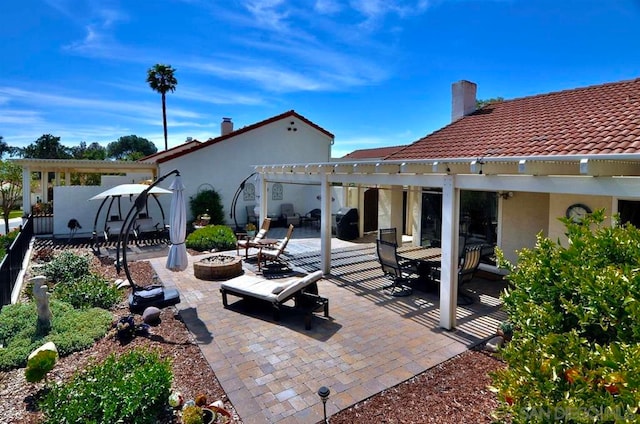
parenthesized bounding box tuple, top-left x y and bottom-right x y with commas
(220, 271, 322, 302)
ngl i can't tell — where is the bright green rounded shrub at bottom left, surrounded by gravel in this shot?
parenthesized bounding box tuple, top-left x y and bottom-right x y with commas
(40, 349, 173, 424)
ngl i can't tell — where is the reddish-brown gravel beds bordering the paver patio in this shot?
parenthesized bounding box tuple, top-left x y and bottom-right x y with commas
(0, 247, 504, 424)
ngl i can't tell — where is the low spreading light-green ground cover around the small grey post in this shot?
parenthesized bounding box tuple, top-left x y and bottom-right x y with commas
(0, 300, 113, 371)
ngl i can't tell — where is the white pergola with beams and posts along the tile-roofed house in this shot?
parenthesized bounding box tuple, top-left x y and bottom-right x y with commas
(255, 154, 640, 329)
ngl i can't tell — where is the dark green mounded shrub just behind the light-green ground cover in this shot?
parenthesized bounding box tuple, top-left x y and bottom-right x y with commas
(53, 273, 123, 309)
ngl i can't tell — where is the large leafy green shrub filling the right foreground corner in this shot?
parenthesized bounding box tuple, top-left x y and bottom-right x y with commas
(493, 211, 640, 423)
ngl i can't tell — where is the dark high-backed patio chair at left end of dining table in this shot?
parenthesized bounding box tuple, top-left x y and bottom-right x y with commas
(376, 239, 419, 297)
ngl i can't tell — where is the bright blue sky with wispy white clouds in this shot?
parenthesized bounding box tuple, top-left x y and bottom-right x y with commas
(0, 0, 640, 157)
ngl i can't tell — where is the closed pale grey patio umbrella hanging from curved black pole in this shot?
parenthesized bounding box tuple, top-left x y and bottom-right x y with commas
(167, 175, 188, 271)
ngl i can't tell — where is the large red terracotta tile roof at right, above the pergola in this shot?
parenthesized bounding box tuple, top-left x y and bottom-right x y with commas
(386, 78, 640, 159)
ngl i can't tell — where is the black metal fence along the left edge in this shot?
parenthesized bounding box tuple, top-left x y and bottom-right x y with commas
(0, 216, 33, 309)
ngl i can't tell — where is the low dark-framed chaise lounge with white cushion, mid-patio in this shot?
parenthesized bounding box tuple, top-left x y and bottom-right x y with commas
(220, 271, 329, 330)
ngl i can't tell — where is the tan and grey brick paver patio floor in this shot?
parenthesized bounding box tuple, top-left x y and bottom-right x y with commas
(150, 229, 506, 424)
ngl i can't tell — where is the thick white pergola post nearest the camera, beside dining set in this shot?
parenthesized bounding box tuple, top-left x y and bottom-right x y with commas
(440, 175, 460, 330)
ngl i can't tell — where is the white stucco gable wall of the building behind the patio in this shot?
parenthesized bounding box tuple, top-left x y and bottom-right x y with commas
(159, 112, 331, 225)
